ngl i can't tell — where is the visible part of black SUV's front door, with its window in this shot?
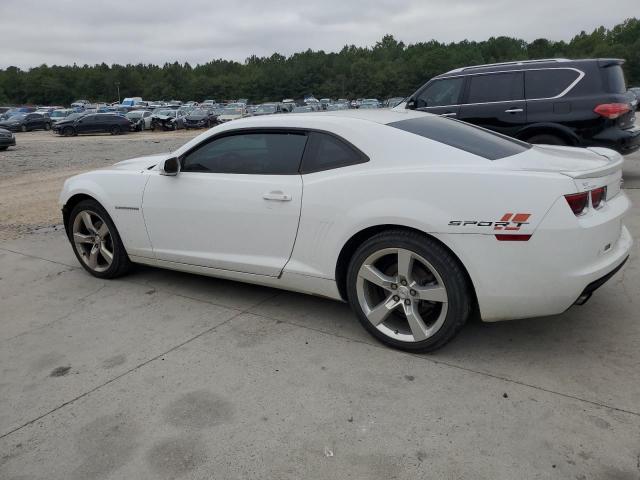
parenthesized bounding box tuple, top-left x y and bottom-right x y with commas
(408, 77, 465, 118)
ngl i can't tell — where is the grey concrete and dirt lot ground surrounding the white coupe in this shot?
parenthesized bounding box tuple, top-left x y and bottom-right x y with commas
(0, 131, 640, 480)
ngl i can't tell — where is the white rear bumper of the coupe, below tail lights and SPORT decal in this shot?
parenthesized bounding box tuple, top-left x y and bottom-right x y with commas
(441, 192, 633, 322)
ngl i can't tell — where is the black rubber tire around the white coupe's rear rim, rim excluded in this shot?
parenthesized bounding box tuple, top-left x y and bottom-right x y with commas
(346, 230, 474, 353)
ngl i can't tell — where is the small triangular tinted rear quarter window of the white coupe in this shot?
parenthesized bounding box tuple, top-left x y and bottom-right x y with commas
(301, 132, 369, 173)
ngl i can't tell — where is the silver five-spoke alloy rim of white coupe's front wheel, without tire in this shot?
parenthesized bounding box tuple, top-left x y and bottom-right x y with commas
(72, 210, 113, 272)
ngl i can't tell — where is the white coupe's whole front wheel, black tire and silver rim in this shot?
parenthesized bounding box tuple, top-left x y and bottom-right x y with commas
(67, 200, 131, 278)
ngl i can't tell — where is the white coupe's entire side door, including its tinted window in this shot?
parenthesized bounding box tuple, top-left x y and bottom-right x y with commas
(143, 130, 307, 276)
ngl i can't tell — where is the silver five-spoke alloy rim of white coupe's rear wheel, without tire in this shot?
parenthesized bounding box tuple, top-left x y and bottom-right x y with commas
(356, 248, 448, 342)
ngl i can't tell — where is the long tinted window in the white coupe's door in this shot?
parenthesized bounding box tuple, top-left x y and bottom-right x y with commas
(182, 132, 307, 175)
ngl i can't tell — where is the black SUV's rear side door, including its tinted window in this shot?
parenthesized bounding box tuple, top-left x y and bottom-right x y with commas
(458, 71, 527, 135)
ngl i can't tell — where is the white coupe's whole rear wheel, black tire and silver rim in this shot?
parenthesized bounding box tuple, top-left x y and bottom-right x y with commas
(347, 230, 472, 352)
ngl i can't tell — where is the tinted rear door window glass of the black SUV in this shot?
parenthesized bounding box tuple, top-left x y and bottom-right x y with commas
(466, 72, 524, 103)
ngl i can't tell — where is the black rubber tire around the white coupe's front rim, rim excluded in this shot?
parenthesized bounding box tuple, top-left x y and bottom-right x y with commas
(66, 199, 131, 279)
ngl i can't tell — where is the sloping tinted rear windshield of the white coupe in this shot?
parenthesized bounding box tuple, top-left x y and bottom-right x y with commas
(388, 115, 531, 160)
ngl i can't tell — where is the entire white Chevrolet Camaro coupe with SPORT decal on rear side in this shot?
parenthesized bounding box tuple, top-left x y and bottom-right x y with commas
(60, 110, 632, 351)
